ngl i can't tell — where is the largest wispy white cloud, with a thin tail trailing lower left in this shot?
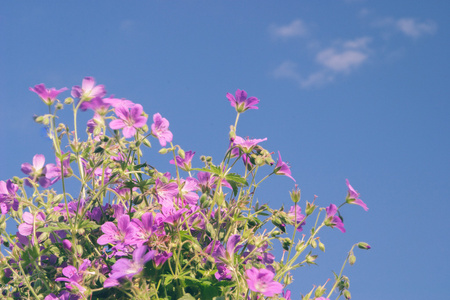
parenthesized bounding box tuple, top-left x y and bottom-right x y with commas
(273, 37, 371, 88)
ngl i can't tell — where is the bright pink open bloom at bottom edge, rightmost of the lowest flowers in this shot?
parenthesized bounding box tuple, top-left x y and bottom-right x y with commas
(245, 267, 283, 297)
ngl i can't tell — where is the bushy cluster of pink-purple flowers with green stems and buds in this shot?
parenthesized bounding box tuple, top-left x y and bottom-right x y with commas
(0, 77, 370, 300)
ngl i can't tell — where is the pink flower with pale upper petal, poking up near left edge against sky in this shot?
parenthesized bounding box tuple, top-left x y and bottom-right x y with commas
(21, 154, 58, 188)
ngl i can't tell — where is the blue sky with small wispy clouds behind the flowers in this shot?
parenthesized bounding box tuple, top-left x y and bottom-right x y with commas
(0, 0, 450, 300)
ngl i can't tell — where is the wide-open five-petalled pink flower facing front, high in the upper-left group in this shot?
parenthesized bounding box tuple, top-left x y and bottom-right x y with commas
(109, 104, 147, 138)
